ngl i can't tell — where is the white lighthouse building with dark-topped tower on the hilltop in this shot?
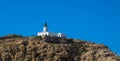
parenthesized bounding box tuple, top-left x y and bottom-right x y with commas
(37, 23, 65, 38)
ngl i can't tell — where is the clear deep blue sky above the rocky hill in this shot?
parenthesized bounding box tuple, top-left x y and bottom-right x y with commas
(0, 0, 120, 55)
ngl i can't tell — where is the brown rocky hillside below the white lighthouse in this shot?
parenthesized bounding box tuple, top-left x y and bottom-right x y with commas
(0, 37, 120, 61)
